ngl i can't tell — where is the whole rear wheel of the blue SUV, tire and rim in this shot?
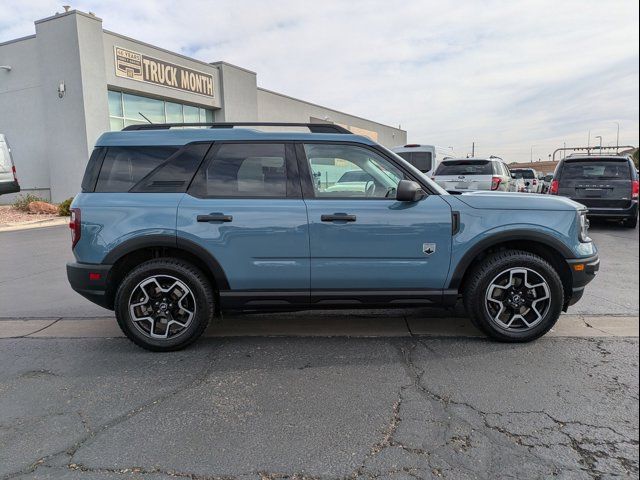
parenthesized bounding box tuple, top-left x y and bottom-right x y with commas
(115, 258, 214, 351)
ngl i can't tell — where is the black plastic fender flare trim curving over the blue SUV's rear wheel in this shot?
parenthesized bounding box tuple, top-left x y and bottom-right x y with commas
(102, 234, 230, 290)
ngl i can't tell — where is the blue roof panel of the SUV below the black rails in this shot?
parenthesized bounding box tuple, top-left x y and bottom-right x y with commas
(96, 127, 376, 147)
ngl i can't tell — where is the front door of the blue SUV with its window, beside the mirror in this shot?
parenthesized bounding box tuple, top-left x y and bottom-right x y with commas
(297, 143, 451, 292)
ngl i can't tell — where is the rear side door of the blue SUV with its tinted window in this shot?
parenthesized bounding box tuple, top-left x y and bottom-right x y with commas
(177, 142, 310, 307)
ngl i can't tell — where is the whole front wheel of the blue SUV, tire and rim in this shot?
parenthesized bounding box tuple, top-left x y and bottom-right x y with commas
(463, 250, 564, 342)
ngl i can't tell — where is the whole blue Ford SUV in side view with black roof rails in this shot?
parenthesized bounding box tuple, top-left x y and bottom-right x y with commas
(67, 124, 599, 351)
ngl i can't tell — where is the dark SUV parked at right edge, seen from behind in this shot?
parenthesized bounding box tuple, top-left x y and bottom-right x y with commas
(549, 155, 638, 228)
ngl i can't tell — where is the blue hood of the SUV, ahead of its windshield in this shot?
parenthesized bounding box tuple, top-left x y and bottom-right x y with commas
(455, 191, 586, 210)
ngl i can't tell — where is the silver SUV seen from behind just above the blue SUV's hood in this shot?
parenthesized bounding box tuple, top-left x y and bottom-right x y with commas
(432, 157, 517, 192)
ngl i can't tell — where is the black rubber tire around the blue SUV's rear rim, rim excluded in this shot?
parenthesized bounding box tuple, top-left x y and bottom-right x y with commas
(115, 258, 215, 352)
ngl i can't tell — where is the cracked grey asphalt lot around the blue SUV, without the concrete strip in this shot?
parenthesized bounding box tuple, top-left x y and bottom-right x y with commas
(0, 220, 639, 480)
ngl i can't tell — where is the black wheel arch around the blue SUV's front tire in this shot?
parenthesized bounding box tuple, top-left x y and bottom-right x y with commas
(449, 230, 573, 301)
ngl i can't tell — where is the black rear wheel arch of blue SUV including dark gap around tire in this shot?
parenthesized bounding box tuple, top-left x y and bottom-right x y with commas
(102, 235, 229, 308)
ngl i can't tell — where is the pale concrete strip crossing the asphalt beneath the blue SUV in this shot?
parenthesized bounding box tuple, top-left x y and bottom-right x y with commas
(0, 314, 639, 338)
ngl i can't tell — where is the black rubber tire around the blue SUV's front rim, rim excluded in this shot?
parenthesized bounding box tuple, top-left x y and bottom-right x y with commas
(462, 250, 564, 342)
